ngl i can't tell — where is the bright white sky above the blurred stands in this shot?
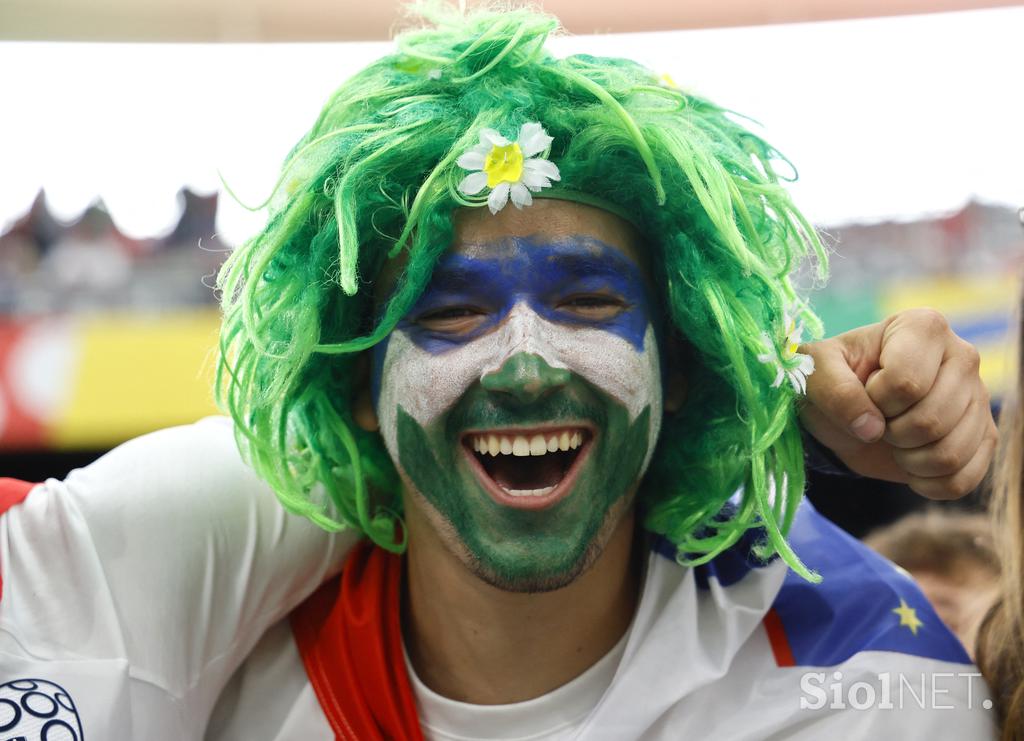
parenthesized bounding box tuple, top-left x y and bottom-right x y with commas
(0, 8, 1024, 244)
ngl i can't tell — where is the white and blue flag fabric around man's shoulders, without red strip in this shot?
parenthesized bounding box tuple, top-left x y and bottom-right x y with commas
(207, 528, 994, 741)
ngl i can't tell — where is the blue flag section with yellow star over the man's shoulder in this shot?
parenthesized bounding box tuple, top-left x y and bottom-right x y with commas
(765, 502, 971, 666)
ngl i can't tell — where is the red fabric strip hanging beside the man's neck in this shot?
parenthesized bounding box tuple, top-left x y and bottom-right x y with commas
(291, 540, 423, 741)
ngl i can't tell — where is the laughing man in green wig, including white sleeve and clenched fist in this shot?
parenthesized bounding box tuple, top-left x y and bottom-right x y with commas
(0, 5, 994, 741)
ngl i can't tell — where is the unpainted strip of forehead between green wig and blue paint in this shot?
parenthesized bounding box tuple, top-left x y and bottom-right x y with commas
(450, 199, 646, 266)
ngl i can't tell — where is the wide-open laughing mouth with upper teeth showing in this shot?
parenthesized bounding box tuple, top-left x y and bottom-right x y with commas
(463, 427, 593, 509)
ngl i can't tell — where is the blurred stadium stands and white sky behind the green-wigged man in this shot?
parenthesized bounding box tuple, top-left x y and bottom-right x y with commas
(0, 0, 1024, 534)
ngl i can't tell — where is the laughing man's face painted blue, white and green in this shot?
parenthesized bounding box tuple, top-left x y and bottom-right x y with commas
(374, 201, 662, 592)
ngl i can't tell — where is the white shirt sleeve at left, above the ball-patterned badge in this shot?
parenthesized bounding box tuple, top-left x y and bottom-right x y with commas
(0, 418, 357, 739)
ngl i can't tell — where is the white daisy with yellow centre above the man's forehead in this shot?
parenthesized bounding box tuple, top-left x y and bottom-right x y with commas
(456, 121, 561, 214)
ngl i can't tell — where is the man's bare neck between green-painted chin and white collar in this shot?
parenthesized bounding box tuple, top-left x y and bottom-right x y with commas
(402, 508, 640, 705)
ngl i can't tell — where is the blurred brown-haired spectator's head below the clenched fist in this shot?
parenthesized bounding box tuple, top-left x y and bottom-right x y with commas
(864, 509, 999, 657)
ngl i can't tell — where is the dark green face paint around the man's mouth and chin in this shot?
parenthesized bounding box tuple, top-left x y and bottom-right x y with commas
(396, 383, 650, 592)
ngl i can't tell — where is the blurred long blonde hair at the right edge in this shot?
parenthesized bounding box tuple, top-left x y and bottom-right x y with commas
(976, 278, 1024, 741)
